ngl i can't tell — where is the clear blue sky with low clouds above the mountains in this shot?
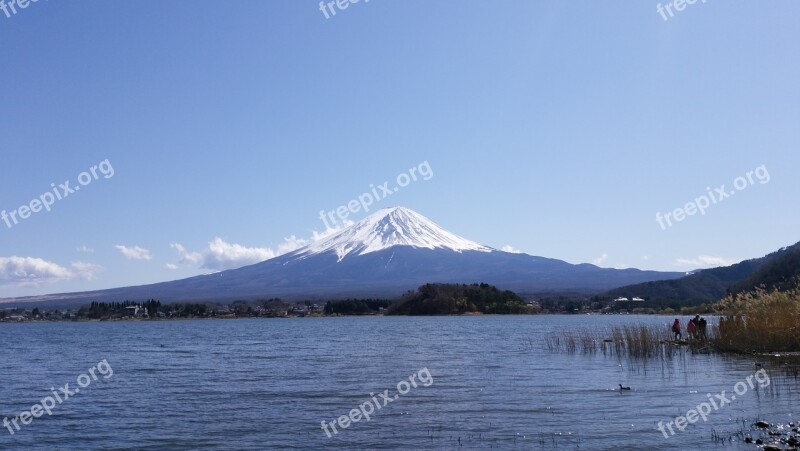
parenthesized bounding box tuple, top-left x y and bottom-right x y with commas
(0, 0, 800, 297)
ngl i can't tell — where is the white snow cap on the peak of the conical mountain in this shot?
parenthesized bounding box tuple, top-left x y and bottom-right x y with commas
(293, 207, 494, 261)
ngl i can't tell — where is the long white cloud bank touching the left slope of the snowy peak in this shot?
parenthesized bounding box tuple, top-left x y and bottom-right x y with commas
(167, 220, 354, 271)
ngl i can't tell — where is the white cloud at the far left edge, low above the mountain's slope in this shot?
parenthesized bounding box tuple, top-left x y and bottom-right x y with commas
(0, 256, 102, 286)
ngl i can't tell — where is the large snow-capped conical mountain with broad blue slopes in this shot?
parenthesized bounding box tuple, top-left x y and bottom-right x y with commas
(3, 207, 683, 303)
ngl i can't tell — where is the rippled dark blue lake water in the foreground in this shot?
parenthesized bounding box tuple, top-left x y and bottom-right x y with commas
(0, 316, 800, 450)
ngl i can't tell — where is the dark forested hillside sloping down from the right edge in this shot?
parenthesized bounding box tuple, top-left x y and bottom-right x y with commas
(606, 243, 800, 304)
